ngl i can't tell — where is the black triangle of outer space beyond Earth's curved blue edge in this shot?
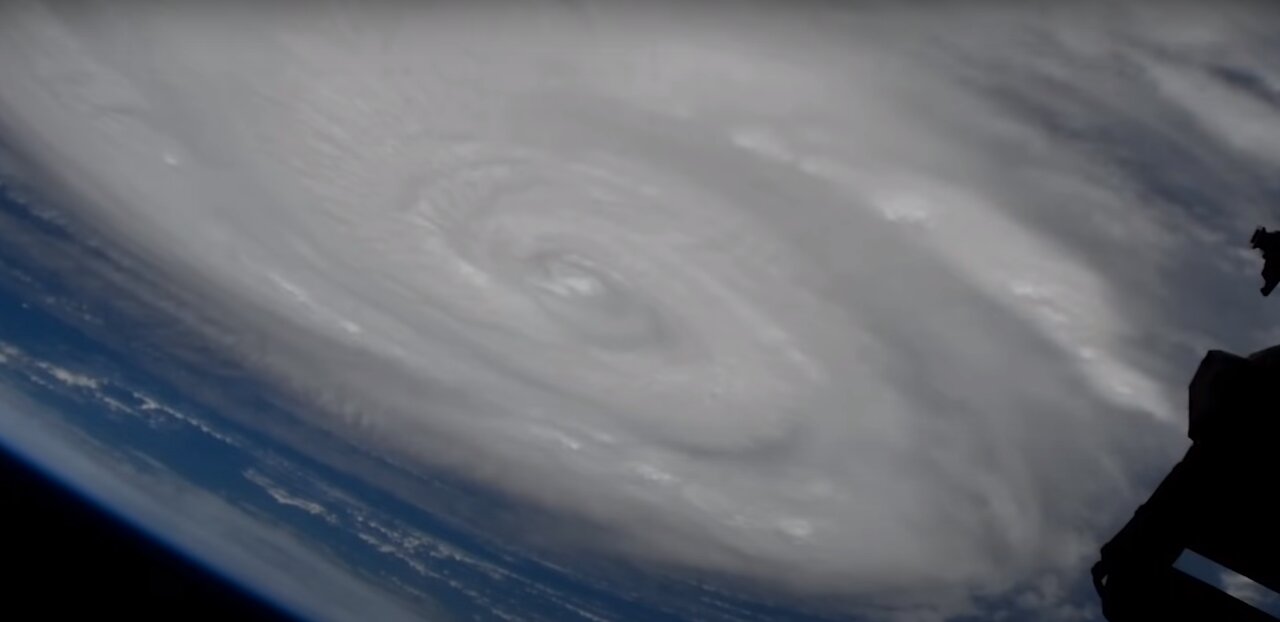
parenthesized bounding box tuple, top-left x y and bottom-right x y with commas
(0, 451, 294, 622)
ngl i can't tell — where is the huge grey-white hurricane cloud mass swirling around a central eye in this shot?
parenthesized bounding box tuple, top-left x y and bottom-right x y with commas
(0, 3, 1280, 612)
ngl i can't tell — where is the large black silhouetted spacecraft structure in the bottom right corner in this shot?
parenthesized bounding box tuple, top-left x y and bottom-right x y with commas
(1093, 348, 1280, 622)
